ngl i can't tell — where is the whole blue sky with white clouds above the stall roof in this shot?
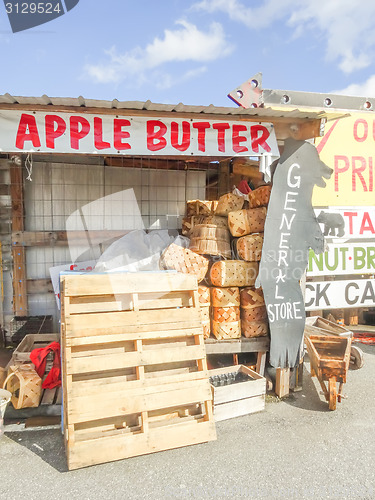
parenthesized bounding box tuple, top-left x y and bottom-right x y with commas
(0, 0, 375, 106)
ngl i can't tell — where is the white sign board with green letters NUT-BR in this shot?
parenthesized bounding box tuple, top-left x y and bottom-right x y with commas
(307, 242, 375, 276)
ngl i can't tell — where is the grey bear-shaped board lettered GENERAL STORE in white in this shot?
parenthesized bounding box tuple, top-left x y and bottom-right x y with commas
(256, 139, 333, 368)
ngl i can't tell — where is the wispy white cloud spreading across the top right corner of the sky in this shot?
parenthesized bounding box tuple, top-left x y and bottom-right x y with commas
(193, 0, 375, 73)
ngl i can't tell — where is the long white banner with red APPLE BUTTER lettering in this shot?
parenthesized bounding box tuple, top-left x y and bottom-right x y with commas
(0, 110, 279, 156)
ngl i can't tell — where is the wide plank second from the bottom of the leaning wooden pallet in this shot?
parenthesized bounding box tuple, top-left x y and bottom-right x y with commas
(68, 380, 212, 424)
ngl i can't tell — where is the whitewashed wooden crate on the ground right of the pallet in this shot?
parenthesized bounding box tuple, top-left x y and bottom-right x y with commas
(209, 365, 266, 422)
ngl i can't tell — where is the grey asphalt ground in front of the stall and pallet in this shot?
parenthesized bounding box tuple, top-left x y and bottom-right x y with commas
(0, 344, 375, 500)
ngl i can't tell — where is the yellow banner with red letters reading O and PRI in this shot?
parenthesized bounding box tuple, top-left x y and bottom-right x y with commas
(313, 112, 375, 207)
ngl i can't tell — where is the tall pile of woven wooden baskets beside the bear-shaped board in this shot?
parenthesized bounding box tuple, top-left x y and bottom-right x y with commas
(160, 185, 271, 340)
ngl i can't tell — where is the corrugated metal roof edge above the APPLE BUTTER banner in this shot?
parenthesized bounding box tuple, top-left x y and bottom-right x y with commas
(0, 94, 344, 120)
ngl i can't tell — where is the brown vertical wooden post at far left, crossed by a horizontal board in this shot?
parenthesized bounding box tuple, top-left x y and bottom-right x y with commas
(10, 164, 28, 316)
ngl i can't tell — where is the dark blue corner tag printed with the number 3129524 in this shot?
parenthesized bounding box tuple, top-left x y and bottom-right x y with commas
(4, 0, 79, 33)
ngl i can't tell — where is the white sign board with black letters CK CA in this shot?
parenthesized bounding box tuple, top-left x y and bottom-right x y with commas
(305, 279, 375, 311)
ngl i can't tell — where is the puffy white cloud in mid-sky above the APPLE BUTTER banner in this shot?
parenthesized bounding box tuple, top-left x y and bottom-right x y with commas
(84, 21, 233, 88)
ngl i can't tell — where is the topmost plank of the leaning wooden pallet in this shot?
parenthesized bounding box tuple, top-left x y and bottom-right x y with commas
(64, 271, 198, 297)
